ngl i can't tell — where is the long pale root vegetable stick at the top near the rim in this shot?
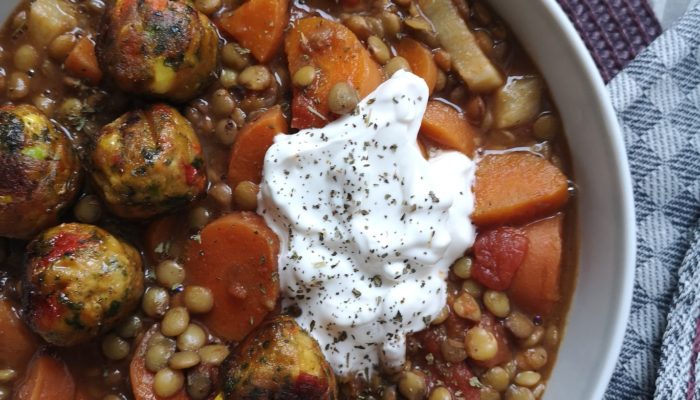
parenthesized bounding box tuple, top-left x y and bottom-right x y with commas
(418, 0, 504, 93)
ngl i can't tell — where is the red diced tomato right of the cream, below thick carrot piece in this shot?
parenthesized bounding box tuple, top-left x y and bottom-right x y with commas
(472, 226, 528, 290)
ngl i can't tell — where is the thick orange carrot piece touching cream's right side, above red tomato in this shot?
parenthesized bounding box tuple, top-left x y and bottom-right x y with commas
(472, 152, 569, 226)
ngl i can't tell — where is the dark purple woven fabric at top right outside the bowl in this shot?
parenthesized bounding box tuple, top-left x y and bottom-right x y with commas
(557, 0, 661, 82)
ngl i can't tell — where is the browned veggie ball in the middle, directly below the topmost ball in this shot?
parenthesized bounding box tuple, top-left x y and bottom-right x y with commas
(88, 104, 207, 218)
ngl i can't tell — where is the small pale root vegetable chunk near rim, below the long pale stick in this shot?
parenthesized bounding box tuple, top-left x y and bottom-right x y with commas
(493, 76, 542, 128)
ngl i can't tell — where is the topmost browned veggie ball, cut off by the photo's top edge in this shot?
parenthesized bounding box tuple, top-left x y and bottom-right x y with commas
(97, 0, 219, 102)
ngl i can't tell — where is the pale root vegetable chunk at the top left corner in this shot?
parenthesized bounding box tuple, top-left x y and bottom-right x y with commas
(27, 0, 78, 46)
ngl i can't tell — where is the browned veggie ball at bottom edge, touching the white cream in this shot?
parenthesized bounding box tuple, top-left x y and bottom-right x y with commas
(221, 316, 337, 400)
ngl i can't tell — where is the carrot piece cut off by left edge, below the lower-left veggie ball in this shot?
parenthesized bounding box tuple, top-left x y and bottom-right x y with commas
(0, 300, 39, 370)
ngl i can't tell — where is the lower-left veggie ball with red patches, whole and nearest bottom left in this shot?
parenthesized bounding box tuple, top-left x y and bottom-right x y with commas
(23, 223, 143, 346)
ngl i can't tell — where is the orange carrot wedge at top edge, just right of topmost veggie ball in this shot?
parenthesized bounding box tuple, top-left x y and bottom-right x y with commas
(216, 0, 289, 63)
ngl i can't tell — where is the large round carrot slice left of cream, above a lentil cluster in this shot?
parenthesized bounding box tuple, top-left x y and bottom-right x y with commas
(185, 212, 280, 342)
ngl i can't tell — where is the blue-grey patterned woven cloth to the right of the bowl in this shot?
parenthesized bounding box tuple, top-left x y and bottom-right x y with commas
(605, 6, 700, 400)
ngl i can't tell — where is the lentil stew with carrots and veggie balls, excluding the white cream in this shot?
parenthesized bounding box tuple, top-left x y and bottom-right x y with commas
(0, 0, 576, 400)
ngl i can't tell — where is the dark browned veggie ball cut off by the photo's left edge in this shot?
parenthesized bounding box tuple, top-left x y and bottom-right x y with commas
(0, 105, 81, 239)
